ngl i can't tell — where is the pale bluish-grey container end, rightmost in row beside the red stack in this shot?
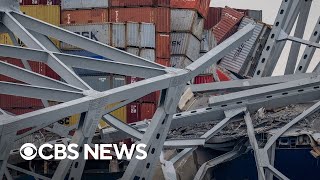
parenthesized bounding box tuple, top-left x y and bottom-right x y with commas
(140, 23, 156, 48)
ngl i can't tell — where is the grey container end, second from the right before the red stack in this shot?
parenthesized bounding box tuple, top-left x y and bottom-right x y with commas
(126, 22, 140, 47)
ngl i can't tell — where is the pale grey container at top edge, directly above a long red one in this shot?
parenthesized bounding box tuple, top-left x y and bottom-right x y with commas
(61, 0, 108, 10)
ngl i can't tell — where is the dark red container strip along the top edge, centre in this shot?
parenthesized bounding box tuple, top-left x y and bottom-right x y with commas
(109, 0, 170, 7)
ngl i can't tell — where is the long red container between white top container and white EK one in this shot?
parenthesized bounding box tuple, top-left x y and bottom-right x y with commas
(61, 9, 109, 24)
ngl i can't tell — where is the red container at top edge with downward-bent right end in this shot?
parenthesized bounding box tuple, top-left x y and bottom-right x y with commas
(170, 0, 210, 18)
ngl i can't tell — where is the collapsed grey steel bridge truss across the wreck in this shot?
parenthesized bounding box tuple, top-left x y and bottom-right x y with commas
(0, 0, 320, 180)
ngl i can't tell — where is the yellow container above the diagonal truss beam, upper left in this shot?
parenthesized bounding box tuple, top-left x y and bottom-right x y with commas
(20, 5, 60, 47)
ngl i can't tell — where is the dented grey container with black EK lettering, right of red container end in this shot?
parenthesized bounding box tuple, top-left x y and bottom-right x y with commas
(171, 32, 200, 61)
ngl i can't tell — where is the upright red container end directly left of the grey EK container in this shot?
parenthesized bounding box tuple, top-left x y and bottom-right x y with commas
(156, 33, 171, 59)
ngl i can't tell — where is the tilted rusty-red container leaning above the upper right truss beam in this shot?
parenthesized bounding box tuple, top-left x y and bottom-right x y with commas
(213, 7, 244, 44)
